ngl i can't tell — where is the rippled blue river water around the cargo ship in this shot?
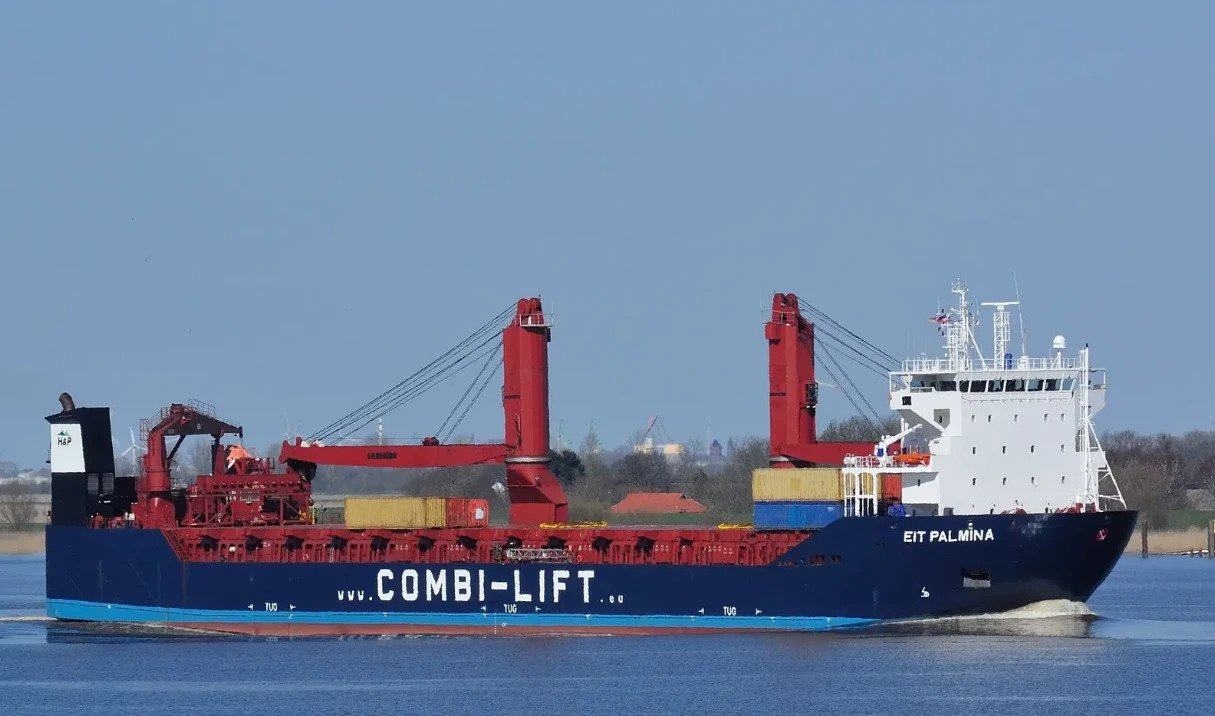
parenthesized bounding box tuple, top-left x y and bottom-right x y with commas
(0, 557, 1215, 716)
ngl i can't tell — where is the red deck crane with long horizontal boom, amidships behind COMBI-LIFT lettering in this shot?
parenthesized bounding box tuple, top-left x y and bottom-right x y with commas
(279, 298, 569, 525)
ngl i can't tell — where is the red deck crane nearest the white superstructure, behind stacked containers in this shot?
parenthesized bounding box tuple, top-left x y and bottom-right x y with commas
(764, 293, 874, 468)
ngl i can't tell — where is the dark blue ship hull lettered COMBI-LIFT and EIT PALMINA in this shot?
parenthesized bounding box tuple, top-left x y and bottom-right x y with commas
(46, 512, 1137, 636)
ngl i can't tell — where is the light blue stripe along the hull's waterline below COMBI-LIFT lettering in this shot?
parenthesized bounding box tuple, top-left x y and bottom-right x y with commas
(46, 599, 875, 631)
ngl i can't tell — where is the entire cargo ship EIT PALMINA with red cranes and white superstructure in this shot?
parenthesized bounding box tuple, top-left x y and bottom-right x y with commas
(46, 288, 1136, 636)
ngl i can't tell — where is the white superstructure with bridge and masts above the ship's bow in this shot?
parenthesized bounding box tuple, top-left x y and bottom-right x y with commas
(844, 286, 1125, 514)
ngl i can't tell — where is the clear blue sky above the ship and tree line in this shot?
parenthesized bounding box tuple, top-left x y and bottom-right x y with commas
(0, 0, 1215, 467)
